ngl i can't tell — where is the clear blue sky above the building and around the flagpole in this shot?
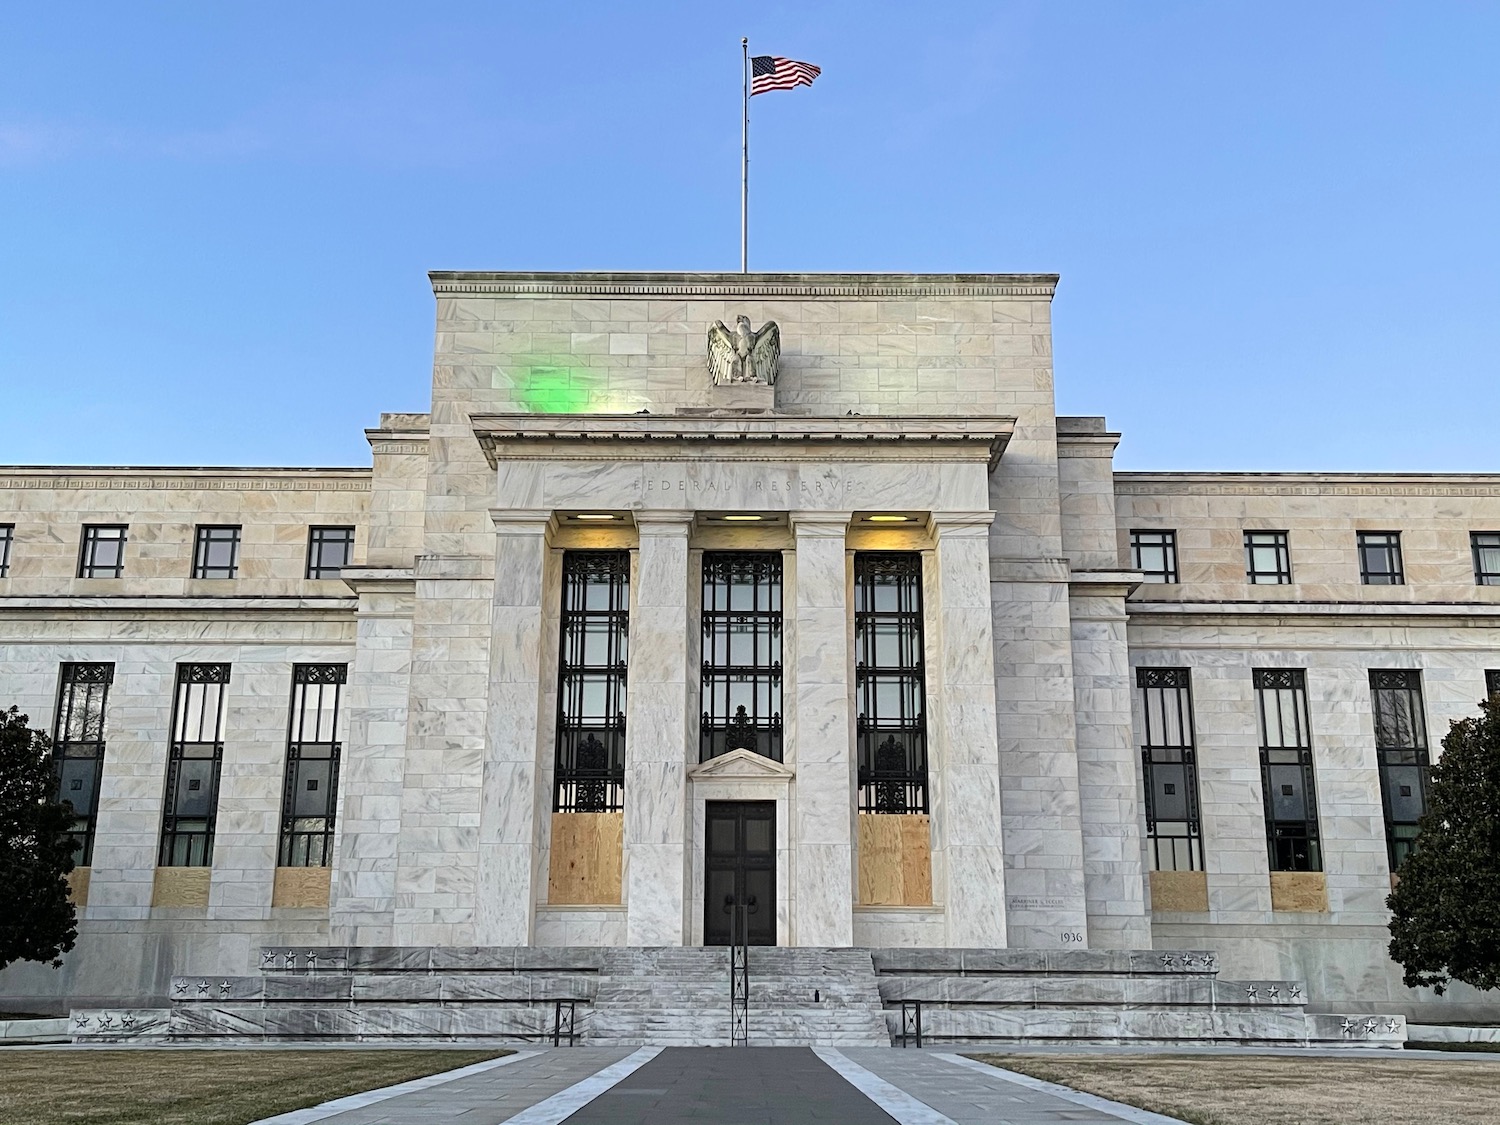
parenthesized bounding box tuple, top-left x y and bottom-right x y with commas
(0, 0, 1500, 471)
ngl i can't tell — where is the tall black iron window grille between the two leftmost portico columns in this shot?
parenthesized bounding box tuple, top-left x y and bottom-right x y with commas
(552, 551, 630, 813)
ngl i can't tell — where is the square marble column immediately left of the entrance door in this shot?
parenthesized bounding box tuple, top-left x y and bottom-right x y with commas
(624, 512, 693, 945)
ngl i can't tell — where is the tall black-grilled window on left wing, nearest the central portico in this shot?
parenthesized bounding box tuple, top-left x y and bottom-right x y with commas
(276, 665, 350, 867)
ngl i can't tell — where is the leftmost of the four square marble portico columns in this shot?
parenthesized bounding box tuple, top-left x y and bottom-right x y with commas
(474, 509, 551, 945)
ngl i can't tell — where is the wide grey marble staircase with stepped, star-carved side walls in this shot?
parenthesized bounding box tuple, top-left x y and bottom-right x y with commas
(69, 947, 1406, 1047)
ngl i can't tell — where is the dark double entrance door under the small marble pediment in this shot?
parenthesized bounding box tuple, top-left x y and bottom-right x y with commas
(704, 801, 776, 945)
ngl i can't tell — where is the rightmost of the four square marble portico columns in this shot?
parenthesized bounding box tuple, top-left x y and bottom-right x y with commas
(932, 512, 1007, 948)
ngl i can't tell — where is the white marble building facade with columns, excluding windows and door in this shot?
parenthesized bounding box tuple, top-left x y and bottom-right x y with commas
(0, 273, 1500, 1013)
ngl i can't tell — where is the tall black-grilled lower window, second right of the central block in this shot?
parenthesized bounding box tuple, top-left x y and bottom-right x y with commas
(1254, 668, 1323, 872)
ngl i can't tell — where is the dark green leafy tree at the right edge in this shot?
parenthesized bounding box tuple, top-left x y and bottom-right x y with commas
(1386, 699, 1500, 995)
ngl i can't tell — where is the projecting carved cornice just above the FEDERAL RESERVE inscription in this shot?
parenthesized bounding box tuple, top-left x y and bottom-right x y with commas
(470, 414, 1016, 471)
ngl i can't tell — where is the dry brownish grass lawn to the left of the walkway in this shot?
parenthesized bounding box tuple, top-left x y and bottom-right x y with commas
(0, 1049, 512, 1125)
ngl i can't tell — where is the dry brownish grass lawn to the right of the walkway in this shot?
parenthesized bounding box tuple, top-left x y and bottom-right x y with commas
(974, 1052, 1500, 1125)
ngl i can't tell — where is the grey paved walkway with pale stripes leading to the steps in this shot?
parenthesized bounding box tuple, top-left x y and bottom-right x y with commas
(257, 1047, 1181, 1125)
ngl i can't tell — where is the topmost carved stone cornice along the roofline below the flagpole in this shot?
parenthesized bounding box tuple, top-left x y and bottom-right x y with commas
(428, 270, 1058, 300)
